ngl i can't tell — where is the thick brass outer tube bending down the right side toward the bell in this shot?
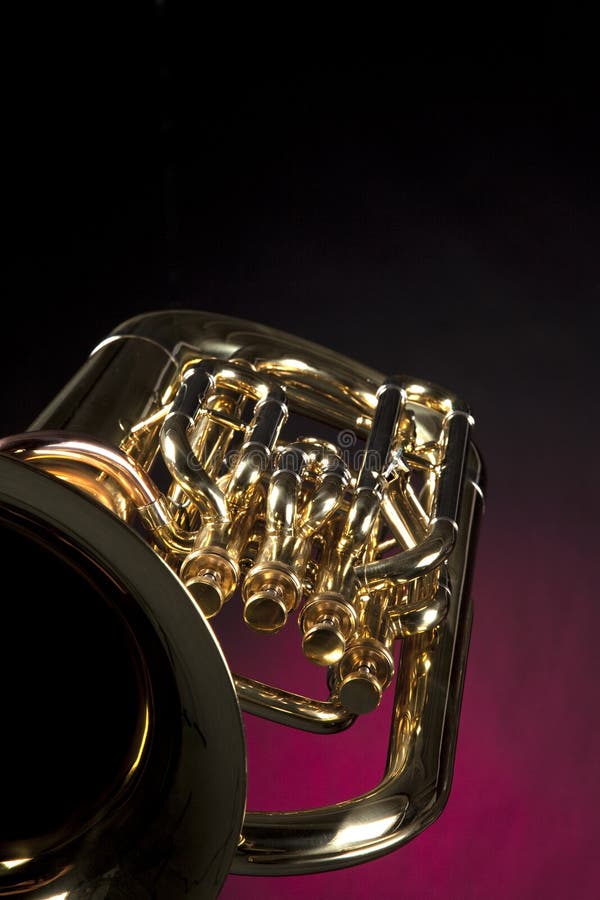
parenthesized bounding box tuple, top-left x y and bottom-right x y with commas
(232, 446, 482, 875)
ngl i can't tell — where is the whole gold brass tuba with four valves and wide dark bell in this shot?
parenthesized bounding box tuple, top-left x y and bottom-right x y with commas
(0, 311, 483, 900)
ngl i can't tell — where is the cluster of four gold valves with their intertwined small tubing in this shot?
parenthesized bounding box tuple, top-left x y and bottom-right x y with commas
(160, 360, 468, 713)
